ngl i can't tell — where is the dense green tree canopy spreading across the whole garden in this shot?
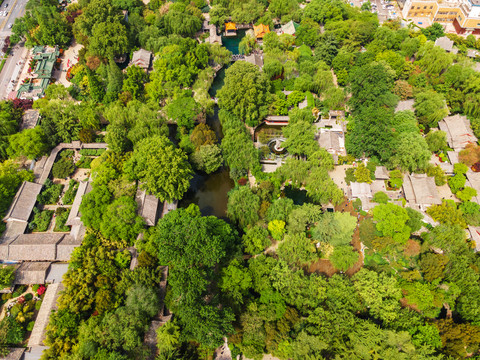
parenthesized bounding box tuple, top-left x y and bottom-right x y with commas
(0, 0, 480, 360)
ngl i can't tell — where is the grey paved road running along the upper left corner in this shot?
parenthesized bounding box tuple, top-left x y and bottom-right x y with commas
(0, 0, 28, 99)
